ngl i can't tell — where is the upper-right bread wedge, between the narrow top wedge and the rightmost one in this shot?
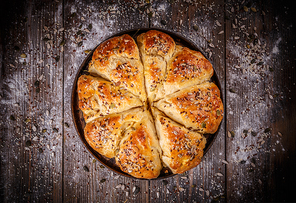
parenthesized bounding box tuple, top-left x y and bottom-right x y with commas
(156, 45, 214, 100)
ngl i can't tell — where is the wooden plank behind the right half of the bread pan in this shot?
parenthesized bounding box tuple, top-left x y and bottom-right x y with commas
(150, 1, 225, 202)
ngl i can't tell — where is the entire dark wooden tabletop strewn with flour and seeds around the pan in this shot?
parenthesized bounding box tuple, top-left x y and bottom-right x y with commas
(0, 0, 296, 203)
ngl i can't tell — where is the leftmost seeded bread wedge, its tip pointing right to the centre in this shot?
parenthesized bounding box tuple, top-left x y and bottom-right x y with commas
(77, 75, 142, 123)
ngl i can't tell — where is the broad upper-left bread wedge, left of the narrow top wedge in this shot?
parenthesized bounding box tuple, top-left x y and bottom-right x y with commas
(88, 34, 146, 102)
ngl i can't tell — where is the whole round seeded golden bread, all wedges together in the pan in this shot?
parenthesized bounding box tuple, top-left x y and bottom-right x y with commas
(77, 30, 223, 179)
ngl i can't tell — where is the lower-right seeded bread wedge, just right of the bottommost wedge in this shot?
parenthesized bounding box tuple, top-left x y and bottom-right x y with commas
(153, 109, 206, 174)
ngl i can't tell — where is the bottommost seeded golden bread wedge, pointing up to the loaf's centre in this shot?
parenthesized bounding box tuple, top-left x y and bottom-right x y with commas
(115, 111, 162, 179)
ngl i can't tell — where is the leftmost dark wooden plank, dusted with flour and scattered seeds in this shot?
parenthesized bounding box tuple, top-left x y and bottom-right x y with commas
(0, 1, 63, 202)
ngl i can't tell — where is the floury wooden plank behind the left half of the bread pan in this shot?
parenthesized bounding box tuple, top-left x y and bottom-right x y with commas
(64, 1, 149, 202)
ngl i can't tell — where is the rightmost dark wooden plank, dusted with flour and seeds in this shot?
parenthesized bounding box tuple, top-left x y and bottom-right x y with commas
(226, 1, 295, 202)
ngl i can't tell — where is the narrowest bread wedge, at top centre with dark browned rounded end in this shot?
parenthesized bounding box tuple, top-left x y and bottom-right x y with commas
(137, 30, 175, 102)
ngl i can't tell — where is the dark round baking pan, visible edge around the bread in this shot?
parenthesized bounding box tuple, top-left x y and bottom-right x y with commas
(71, 28, 223, 180)
